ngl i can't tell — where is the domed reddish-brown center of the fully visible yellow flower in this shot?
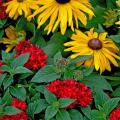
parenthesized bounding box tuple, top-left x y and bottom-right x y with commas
(88, 38, 102, 50)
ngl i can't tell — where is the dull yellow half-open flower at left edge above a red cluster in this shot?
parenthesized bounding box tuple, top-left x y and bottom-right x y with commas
(0, 26, 26, 52)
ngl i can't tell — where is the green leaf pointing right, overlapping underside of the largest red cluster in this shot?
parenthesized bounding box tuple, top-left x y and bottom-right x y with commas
(58, 98, 75, 108)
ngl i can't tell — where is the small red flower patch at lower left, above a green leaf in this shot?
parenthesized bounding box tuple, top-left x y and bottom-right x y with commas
(11, 98, 27, 110)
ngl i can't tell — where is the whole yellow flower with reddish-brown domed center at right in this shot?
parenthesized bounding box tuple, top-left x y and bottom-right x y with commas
(64, 28, 120, 73)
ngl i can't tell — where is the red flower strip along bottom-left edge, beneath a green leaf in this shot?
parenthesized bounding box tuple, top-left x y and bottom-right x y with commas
(0, 112, 28, 120)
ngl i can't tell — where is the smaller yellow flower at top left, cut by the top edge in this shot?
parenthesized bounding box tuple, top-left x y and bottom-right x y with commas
(5, 0, 39, 19)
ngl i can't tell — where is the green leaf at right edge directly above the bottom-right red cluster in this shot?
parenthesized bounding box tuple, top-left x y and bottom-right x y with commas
(103, 98, 120, 115)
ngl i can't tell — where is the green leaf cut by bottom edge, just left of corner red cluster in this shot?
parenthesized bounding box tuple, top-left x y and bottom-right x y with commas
(91, 110, 107, 120)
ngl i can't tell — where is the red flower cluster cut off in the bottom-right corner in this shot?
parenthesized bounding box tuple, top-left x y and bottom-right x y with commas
(109, 108, 120, 120)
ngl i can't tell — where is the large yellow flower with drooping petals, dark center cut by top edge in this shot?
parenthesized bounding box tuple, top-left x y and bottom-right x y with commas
(28, 0, 94, 34)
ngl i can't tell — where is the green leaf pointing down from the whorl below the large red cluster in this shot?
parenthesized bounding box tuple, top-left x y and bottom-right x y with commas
(45, 106, 58, 120)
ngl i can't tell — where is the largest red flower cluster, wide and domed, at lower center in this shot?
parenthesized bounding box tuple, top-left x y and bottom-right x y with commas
(47, 79, 92, 108)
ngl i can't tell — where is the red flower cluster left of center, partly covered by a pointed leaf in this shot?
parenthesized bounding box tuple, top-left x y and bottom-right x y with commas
(15, 41, 48, 70)
